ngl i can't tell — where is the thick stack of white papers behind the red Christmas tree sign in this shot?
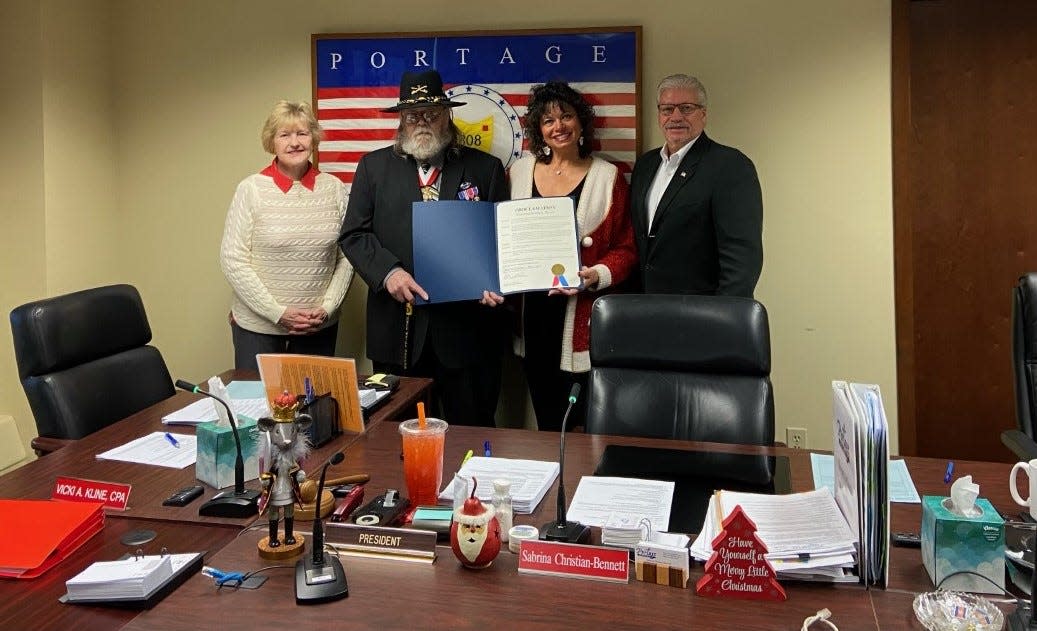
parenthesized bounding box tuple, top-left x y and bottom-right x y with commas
(691, 489, 857, 581)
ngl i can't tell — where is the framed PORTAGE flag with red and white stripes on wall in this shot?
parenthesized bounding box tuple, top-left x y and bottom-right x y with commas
(311, 26, 641, 193)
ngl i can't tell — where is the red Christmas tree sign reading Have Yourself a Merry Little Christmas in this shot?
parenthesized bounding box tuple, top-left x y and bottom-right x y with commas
(695, 506, 787, 600)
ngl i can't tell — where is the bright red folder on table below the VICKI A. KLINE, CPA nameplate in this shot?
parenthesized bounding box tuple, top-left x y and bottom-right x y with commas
(0, 499, 105, 578)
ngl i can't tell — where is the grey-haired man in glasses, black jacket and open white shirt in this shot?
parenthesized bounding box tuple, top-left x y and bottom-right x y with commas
(630, 75, 763, 298)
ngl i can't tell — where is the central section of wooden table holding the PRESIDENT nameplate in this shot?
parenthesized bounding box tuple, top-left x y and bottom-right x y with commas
(127, 423, 1012, 631)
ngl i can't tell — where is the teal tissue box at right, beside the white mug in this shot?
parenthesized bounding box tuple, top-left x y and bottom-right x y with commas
(922, 495, 1005, 594)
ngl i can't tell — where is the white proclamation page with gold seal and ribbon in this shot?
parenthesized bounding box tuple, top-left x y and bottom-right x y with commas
(497, 197, 581, 294)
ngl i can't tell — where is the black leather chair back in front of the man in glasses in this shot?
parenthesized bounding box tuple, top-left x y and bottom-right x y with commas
(587, 295, 775, 445)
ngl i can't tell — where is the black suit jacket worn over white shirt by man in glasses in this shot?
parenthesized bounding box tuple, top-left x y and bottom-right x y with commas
(630, 133, 763, 298)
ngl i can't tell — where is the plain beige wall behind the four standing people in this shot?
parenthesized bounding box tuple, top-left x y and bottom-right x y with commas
(0, 0, 896, 448)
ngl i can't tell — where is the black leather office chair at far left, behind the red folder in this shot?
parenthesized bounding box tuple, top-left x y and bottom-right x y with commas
(10, 284, 174, 455)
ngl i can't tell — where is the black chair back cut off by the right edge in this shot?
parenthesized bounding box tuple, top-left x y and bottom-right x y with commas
(1012, 273, 1037, 438)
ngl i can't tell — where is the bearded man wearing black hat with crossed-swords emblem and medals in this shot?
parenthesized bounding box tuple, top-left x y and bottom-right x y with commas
(338, 71, 508, 427)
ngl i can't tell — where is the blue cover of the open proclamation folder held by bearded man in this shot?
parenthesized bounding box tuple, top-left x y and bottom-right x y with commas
(412, 199, 579, 303)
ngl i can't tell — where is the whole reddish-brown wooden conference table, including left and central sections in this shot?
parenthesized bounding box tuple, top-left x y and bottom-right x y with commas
(0, 383, 1016, 631)
